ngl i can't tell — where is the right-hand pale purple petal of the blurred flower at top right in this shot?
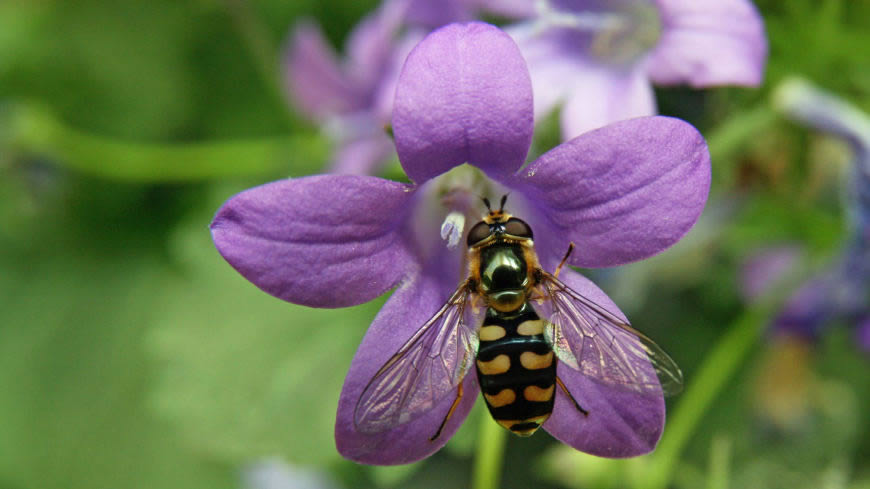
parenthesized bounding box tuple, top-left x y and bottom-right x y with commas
(649, 0, 767, 87)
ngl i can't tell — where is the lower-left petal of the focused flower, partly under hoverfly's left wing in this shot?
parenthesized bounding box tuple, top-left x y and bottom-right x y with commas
(335, 278, 478, 465)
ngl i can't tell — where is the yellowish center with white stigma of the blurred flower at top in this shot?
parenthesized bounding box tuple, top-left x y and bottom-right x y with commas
(537, 0, 662, 66)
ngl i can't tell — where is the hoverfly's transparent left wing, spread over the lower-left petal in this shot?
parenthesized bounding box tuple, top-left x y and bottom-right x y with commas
(354, 282, 482, 433)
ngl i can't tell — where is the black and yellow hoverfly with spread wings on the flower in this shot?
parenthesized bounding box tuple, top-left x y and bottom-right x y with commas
(354, 196, 682, 440)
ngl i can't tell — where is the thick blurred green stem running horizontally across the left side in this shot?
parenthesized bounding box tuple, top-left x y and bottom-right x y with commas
(4, 105, 328, 182)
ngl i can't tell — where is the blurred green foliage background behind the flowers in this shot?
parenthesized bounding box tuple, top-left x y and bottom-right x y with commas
(0, 0, 870, 489)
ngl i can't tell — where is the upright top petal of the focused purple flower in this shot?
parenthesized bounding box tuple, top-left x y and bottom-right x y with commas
(393, 22, 533, 182)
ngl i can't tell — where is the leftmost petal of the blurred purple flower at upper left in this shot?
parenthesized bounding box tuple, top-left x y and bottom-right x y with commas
(284, 22, 365, 120)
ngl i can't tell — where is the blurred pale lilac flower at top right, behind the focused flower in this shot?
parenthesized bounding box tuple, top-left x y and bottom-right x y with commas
(508, 0, 767, 139)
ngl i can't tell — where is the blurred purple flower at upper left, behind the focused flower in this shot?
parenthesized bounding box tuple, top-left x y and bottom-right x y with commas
(285, 0, 422, 174)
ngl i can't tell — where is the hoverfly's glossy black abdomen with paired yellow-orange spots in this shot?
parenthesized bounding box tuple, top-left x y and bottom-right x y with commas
(477, 303, 556, 436)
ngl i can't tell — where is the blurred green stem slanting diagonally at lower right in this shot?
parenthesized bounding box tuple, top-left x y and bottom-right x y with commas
(637, 301, 778, 489)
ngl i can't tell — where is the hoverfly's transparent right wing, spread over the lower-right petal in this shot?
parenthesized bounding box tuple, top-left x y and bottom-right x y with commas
(536, 273, 683, 395)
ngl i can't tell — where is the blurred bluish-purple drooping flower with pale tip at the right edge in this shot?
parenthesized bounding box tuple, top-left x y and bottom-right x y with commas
(773, 80, 870, 351)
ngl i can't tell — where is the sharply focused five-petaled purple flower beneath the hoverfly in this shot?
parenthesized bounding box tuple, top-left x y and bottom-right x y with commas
(211, 23, 710, 464)
